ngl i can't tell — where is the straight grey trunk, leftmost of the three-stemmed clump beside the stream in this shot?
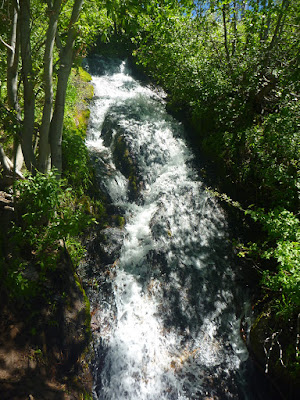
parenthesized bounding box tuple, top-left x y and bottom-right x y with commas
(20, 0, 35, 171)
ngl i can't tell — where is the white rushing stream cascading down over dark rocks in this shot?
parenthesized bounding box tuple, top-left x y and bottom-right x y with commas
(82, 57, 272, 400)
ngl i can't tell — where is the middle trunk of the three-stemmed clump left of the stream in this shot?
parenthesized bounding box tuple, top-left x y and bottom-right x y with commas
(38, 0, 62, 173)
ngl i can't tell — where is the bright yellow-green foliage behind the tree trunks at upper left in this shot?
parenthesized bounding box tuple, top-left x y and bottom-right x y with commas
(0, 0, 112, 174)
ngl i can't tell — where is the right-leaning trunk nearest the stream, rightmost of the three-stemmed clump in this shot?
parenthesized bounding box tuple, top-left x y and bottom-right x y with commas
(50, 0, 83, 177)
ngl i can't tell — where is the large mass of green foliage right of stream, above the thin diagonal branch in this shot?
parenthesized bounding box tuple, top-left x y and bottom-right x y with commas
(134, 0, 300, 211)
